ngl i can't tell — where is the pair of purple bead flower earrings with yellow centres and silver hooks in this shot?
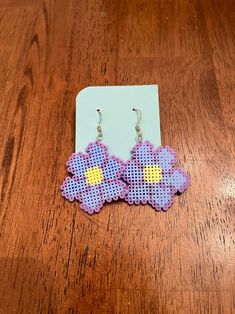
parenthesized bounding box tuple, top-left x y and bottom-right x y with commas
(61, 108, 189, 214)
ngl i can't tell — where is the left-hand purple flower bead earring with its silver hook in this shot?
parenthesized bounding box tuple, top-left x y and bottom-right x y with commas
(61, 109, 127, 214)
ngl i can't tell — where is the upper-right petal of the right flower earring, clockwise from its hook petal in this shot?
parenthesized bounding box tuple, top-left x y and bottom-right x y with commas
(155, 146, 176, 171)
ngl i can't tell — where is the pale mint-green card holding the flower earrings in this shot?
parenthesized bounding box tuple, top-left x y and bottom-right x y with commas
(75, 85, 161, 160)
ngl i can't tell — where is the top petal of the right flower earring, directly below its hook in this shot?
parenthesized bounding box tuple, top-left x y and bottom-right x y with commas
(132, 141, 156, 166)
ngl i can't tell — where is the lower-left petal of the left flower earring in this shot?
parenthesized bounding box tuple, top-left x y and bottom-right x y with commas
(60, 177, 86, 202)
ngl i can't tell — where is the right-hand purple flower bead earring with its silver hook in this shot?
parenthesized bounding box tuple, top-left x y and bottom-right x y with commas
(122, 108, 189, 211)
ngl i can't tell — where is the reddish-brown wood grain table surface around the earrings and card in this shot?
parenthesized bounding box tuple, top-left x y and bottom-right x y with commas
(0, 0, 235, 314)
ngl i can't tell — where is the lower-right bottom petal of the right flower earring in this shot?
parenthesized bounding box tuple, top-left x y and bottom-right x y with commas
(149, 184, 174, 210)
